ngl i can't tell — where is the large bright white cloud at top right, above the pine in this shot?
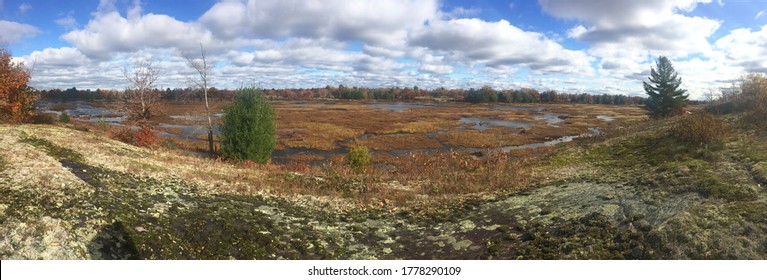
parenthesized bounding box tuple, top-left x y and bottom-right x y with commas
(539, 0, 720, 56)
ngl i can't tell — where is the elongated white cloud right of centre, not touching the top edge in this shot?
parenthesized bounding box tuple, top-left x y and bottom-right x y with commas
(411, 19, 590, 74)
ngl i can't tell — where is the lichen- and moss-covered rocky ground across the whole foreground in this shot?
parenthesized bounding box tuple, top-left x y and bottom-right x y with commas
(0, 112, 767, 259)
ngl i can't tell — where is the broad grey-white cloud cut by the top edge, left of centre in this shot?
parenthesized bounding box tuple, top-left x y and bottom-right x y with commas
(200, 0, 439, 46)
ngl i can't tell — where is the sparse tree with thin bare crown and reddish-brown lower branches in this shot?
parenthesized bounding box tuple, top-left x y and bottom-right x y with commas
(122, 61, 160, 122)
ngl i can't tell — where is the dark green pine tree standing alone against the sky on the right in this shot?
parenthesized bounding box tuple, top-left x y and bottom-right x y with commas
(642, 56, 688, 117)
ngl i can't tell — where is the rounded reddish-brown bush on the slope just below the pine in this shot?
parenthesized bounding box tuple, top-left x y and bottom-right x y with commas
(673, 112, 727, 146)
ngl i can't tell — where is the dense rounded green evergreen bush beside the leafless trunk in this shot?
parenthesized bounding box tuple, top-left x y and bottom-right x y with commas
(220, 88, 276, 163)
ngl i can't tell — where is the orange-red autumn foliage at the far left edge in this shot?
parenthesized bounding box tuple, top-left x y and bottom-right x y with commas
(0, 48, 38, 122)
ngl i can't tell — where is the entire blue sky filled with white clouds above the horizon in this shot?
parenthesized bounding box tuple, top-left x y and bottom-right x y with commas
(0, 0, 767, 98)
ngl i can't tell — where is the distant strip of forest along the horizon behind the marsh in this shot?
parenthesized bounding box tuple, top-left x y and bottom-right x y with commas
(40, 85, 646, 105)
